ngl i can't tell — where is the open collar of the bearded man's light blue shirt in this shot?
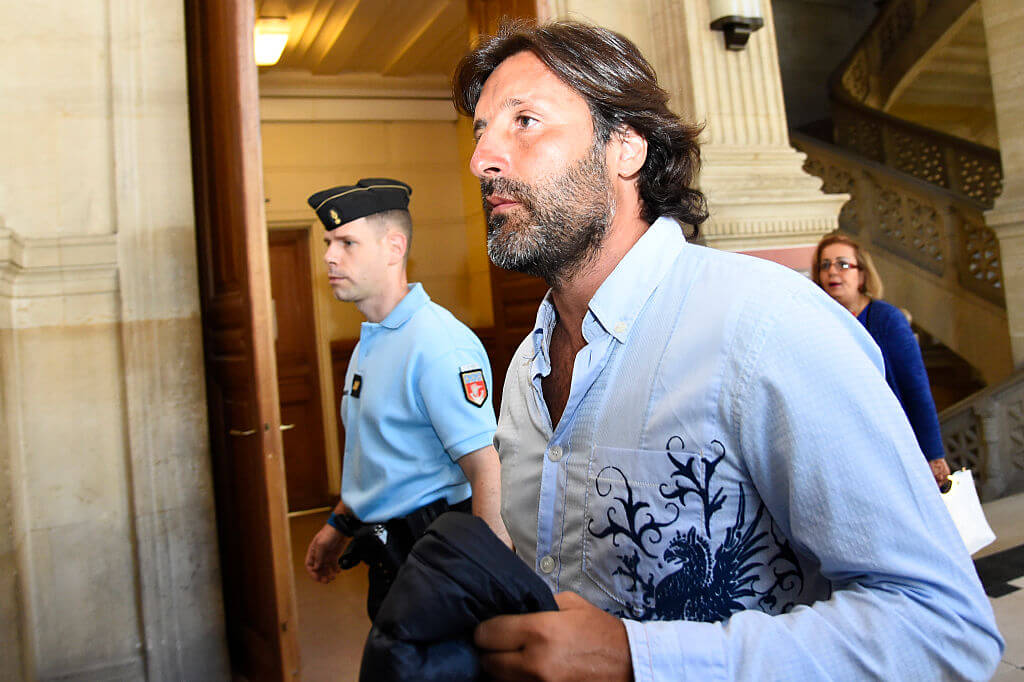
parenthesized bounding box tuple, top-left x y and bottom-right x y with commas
(532, 216, 686, 359)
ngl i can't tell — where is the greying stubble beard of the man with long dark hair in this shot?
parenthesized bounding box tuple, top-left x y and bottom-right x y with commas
(480, 141, 614, 287)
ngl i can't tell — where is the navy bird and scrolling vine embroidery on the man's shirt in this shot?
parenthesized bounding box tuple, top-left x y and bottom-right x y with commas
(588, 436, 804, 623)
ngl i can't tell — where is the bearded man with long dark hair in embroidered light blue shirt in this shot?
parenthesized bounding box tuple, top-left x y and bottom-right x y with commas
(454, 23, 1002, 680)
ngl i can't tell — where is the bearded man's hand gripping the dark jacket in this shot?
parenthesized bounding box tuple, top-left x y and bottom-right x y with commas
(473, 592, 633, 682)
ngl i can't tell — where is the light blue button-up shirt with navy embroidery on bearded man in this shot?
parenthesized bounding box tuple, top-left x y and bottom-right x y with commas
(495, 218, 1002, 682)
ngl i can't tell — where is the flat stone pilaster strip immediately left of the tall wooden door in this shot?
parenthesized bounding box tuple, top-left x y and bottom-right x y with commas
(106, 0, 229, 681)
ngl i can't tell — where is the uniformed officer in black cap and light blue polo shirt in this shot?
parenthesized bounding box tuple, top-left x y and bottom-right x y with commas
(306, 178, 511, 619)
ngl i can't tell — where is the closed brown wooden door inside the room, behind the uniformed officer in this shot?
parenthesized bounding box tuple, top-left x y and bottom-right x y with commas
(269, 228, 331, 511)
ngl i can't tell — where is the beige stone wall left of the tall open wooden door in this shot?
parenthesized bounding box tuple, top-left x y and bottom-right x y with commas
(0, 0, 227, 680)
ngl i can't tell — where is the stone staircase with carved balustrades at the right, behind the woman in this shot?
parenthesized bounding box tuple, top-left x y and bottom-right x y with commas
(791, 0, 1024, 499)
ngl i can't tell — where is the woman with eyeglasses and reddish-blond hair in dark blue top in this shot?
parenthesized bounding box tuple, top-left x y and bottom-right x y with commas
(811, 232, 949, 489)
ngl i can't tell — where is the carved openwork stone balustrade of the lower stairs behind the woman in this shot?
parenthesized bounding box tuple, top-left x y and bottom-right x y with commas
(793, 133, 1024, 500)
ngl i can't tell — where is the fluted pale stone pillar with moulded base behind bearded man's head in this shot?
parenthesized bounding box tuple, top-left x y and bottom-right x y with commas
(539, 0, 848, 266)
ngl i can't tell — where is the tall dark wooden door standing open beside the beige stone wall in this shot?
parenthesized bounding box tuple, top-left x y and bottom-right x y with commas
(185, 0, 299, 682)
